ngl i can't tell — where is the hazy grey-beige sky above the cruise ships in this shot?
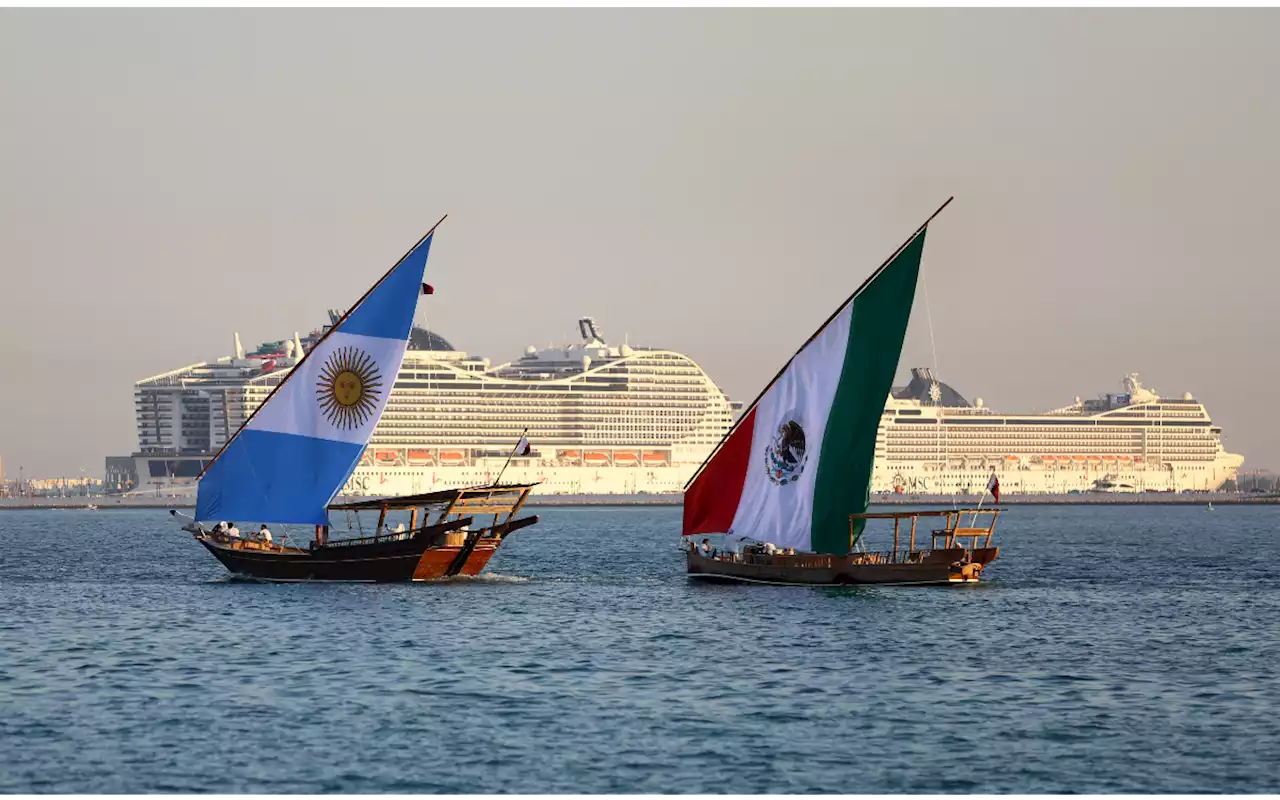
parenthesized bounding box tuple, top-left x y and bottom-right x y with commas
(0, 9, 1280, 476)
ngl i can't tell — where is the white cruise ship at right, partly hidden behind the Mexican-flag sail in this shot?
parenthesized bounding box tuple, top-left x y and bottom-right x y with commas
(872, 369, 1244, 494)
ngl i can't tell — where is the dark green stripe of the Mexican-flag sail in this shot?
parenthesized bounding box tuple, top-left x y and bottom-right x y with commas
(809, 230, 924, 554)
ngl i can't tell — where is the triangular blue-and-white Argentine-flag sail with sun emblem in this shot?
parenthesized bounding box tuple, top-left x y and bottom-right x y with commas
(196, 219, 444, 525)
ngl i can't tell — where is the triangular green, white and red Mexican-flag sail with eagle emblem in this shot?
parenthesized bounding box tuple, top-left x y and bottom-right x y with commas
(684, 200, 951, 554)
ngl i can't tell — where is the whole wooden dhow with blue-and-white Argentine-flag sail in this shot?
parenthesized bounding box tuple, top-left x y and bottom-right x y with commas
(170, 219, 538, 581)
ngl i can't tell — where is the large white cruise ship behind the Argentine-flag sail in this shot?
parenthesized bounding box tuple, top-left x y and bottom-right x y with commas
(134, 311, 739, 495)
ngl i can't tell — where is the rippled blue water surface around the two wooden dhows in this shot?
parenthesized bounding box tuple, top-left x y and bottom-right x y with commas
(0, 507, 1280, 794)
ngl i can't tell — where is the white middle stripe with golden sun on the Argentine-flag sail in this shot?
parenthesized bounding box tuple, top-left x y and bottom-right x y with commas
(246, 329, 406, 444)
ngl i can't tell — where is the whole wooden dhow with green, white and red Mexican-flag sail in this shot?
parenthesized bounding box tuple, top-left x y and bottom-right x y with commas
(684, 200, 1000, 585)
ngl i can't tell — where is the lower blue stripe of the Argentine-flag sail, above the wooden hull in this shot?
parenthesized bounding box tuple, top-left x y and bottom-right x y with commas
(196, 430, 365, 525)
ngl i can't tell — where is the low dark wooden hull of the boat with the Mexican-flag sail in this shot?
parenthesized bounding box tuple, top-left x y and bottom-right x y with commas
(687, 547, 1000, 586)
